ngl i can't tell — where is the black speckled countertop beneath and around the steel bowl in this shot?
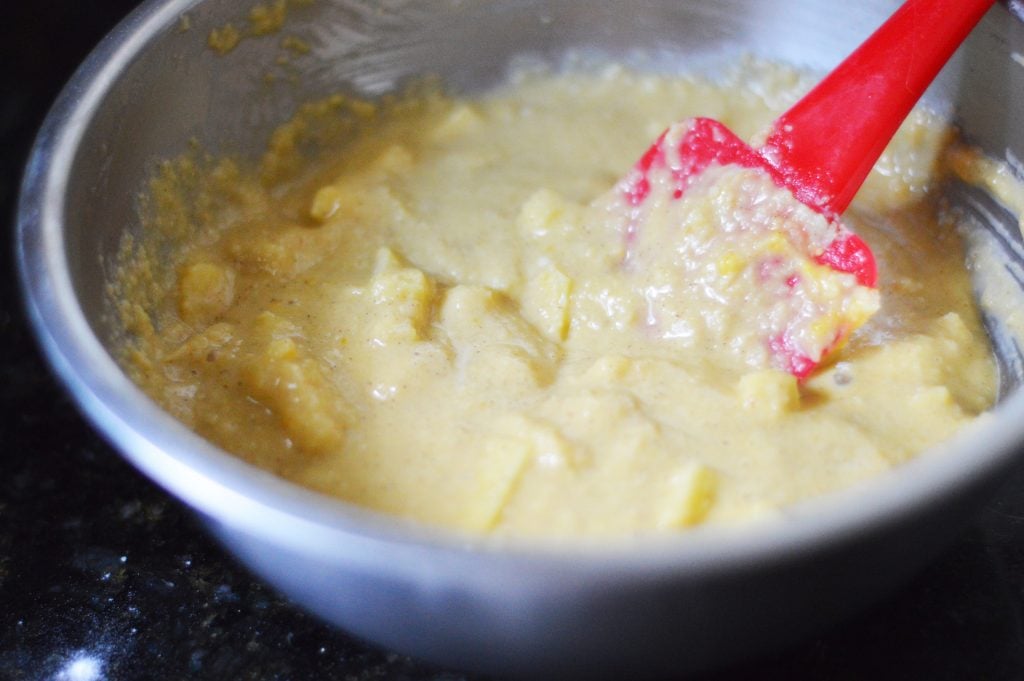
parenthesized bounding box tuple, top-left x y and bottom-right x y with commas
(6, 0, 1024, 681)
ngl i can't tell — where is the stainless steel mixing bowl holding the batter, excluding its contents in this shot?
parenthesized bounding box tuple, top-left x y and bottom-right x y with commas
(16, 0, 1024, 676)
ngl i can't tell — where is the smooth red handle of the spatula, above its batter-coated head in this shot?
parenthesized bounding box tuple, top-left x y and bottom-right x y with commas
(761, 0, 994, 215)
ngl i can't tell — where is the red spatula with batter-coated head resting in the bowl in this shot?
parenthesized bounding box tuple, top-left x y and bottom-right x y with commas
(616, 0, 993, 379)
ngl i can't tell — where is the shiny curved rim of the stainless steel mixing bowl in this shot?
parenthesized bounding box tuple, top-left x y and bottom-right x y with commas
(15, 0, 1024, 576)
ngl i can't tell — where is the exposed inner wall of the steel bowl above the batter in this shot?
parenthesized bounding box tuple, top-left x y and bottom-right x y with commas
(29, 0, 1024, 540)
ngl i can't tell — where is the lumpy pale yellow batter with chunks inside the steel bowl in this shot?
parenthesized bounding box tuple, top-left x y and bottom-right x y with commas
(120, 65, 995, 537)
